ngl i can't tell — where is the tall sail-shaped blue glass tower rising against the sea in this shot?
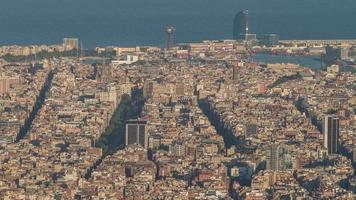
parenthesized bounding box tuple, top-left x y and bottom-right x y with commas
(233, 10, 248, 40)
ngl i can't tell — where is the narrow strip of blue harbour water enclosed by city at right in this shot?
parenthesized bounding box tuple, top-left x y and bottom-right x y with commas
(250, 54, 321, 69)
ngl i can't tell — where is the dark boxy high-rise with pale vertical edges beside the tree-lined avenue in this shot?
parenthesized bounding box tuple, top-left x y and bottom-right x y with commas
(125, 120, 148, 148)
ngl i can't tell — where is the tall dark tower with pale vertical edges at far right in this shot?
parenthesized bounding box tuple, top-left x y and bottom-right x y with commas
(323, 115, 340, 154)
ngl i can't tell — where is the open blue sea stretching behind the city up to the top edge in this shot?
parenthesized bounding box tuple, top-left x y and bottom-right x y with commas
(0, 0, 356, 47)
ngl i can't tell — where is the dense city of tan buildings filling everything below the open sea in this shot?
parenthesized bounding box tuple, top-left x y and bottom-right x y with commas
(0, 1, 356, 200)
